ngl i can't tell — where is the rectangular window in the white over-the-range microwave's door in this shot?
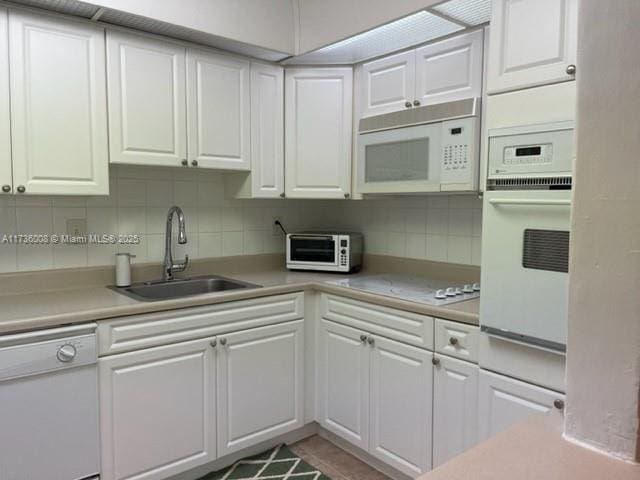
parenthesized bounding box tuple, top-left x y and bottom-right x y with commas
(364, 138, 429, 183)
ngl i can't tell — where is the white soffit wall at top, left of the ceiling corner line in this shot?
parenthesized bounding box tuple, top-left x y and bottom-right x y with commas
(87, 0, 295, 54)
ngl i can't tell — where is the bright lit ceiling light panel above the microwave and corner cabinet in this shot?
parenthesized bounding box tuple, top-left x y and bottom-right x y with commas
(285, 10, 464, 65)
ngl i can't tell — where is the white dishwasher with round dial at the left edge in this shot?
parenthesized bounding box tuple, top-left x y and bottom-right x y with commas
(0, 324, 99, 480)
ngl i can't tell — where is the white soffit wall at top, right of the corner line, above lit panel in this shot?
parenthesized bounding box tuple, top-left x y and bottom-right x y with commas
(296, 0, 441, 54)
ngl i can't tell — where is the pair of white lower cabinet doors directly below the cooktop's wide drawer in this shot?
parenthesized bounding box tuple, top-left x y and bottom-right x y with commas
(318, 320, 433, 477)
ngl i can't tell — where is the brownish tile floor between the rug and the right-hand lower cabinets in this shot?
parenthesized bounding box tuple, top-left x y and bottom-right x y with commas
(289, 435, 390, 480)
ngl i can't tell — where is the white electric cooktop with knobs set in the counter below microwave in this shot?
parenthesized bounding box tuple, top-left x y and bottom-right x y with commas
(327, 274, 480, 305)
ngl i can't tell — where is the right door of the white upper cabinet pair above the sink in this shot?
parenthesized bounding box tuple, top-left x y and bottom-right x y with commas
(187, 49, 251, 170)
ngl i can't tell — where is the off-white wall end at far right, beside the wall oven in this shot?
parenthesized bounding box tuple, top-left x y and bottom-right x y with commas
(565, 0, 640, 460)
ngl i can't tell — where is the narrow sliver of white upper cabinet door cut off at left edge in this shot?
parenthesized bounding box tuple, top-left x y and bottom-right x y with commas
(0, 8, 13, 195)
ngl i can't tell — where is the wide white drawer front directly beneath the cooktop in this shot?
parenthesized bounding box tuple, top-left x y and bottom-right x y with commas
(320, 295, 433, 350)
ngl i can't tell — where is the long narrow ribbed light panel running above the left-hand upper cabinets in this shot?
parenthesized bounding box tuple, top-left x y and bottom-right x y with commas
(4, 0, 289, 62)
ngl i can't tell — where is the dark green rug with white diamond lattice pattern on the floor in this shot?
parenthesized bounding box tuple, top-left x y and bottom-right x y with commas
(200, 445, 331, 480)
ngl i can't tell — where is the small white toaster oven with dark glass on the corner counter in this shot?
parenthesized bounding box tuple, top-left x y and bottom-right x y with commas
(287, 232, 363, 273)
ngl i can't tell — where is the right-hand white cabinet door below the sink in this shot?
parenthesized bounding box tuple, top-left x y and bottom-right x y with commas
(217, 320, 304, 456)
